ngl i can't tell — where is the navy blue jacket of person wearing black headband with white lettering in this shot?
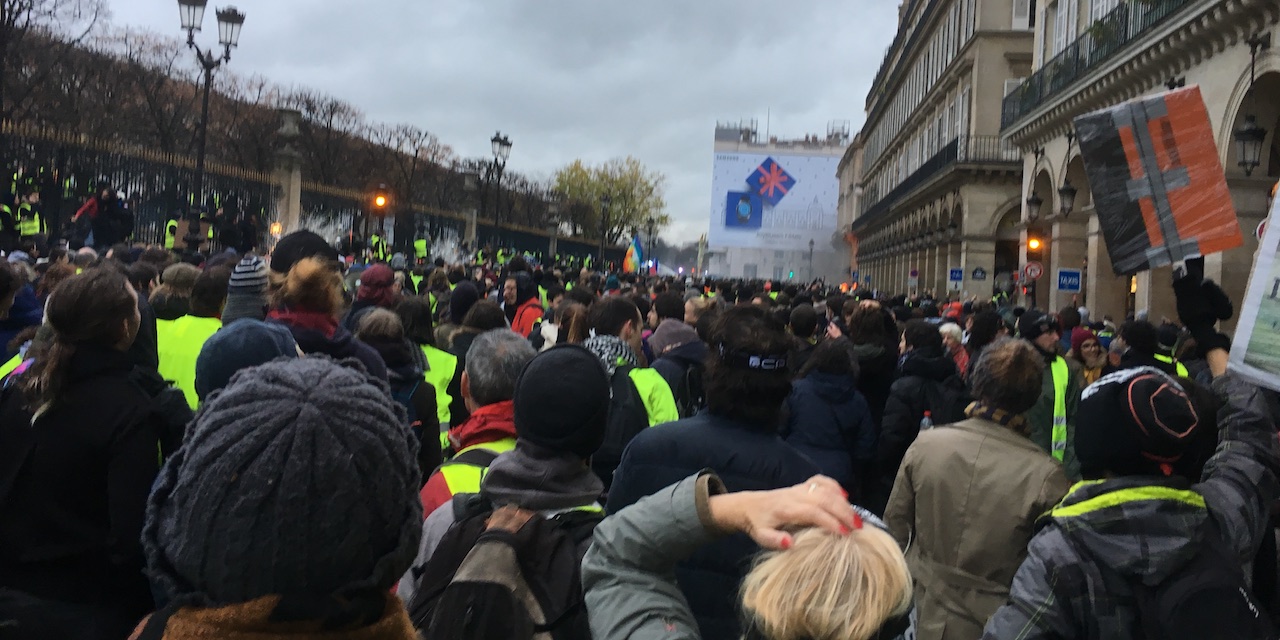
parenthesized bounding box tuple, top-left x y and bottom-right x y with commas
(607, 411, 819, 640)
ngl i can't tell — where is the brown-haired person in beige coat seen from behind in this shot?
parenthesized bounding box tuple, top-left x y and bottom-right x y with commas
(884, 338, 1070, 640)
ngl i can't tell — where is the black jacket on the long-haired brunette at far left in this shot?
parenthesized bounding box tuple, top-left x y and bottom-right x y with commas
(0, 346, 161, 637)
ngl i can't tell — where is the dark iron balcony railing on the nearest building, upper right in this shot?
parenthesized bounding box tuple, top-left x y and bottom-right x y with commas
(1000, 0, 1193, 129)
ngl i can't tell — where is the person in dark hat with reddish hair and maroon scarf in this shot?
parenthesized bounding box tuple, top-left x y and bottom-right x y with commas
(268, 230, 387, 380)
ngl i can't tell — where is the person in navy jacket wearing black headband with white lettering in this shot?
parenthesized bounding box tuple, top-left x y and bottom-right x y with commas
(602, 302, 818, 640)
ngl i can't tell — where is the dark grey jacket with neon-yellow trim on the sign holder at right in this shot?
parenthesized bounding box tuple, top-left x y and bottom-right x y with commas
(983, 374, 1280, 640)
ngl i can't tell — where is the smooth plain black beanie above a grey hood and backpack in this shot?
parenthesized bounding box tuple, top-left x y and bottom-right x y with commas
(515, 344, 609, 460)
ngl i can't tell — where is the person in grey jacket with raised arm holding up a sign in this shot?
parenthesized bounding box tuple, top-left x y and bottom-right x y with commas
(983, 268, 1280, 640)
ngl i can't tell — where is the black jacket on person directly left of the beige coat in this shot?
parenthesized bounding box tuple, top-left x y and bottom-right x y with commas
(865, 351, 965, 513)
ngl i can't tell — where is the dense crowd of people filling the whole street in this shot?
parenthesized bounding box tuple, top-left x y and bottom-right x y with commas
(0, 230, 1280, 640)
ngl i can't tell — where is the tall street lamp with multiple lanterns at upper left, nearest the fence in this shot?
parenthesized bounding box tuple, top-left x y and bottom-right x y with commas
(178, 0, 244, 251)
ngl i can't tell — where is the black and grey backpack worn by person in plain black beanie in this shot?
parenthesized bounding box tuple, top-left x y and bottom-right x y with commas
(408, 494, 603, 640)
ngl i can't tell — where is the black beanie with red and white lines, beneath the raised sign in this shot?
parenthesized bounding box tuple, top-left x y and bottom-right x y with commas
(1075, 366, 1201, 476)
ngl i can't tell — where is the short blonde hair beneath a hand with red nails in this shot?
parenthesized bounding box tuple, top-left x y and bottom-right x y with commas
(742, 526, 911, 640)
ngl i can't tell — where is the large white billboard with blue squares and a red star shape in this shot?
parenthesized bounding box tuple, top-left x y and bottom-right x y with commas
(707, 152, 840, 251)
